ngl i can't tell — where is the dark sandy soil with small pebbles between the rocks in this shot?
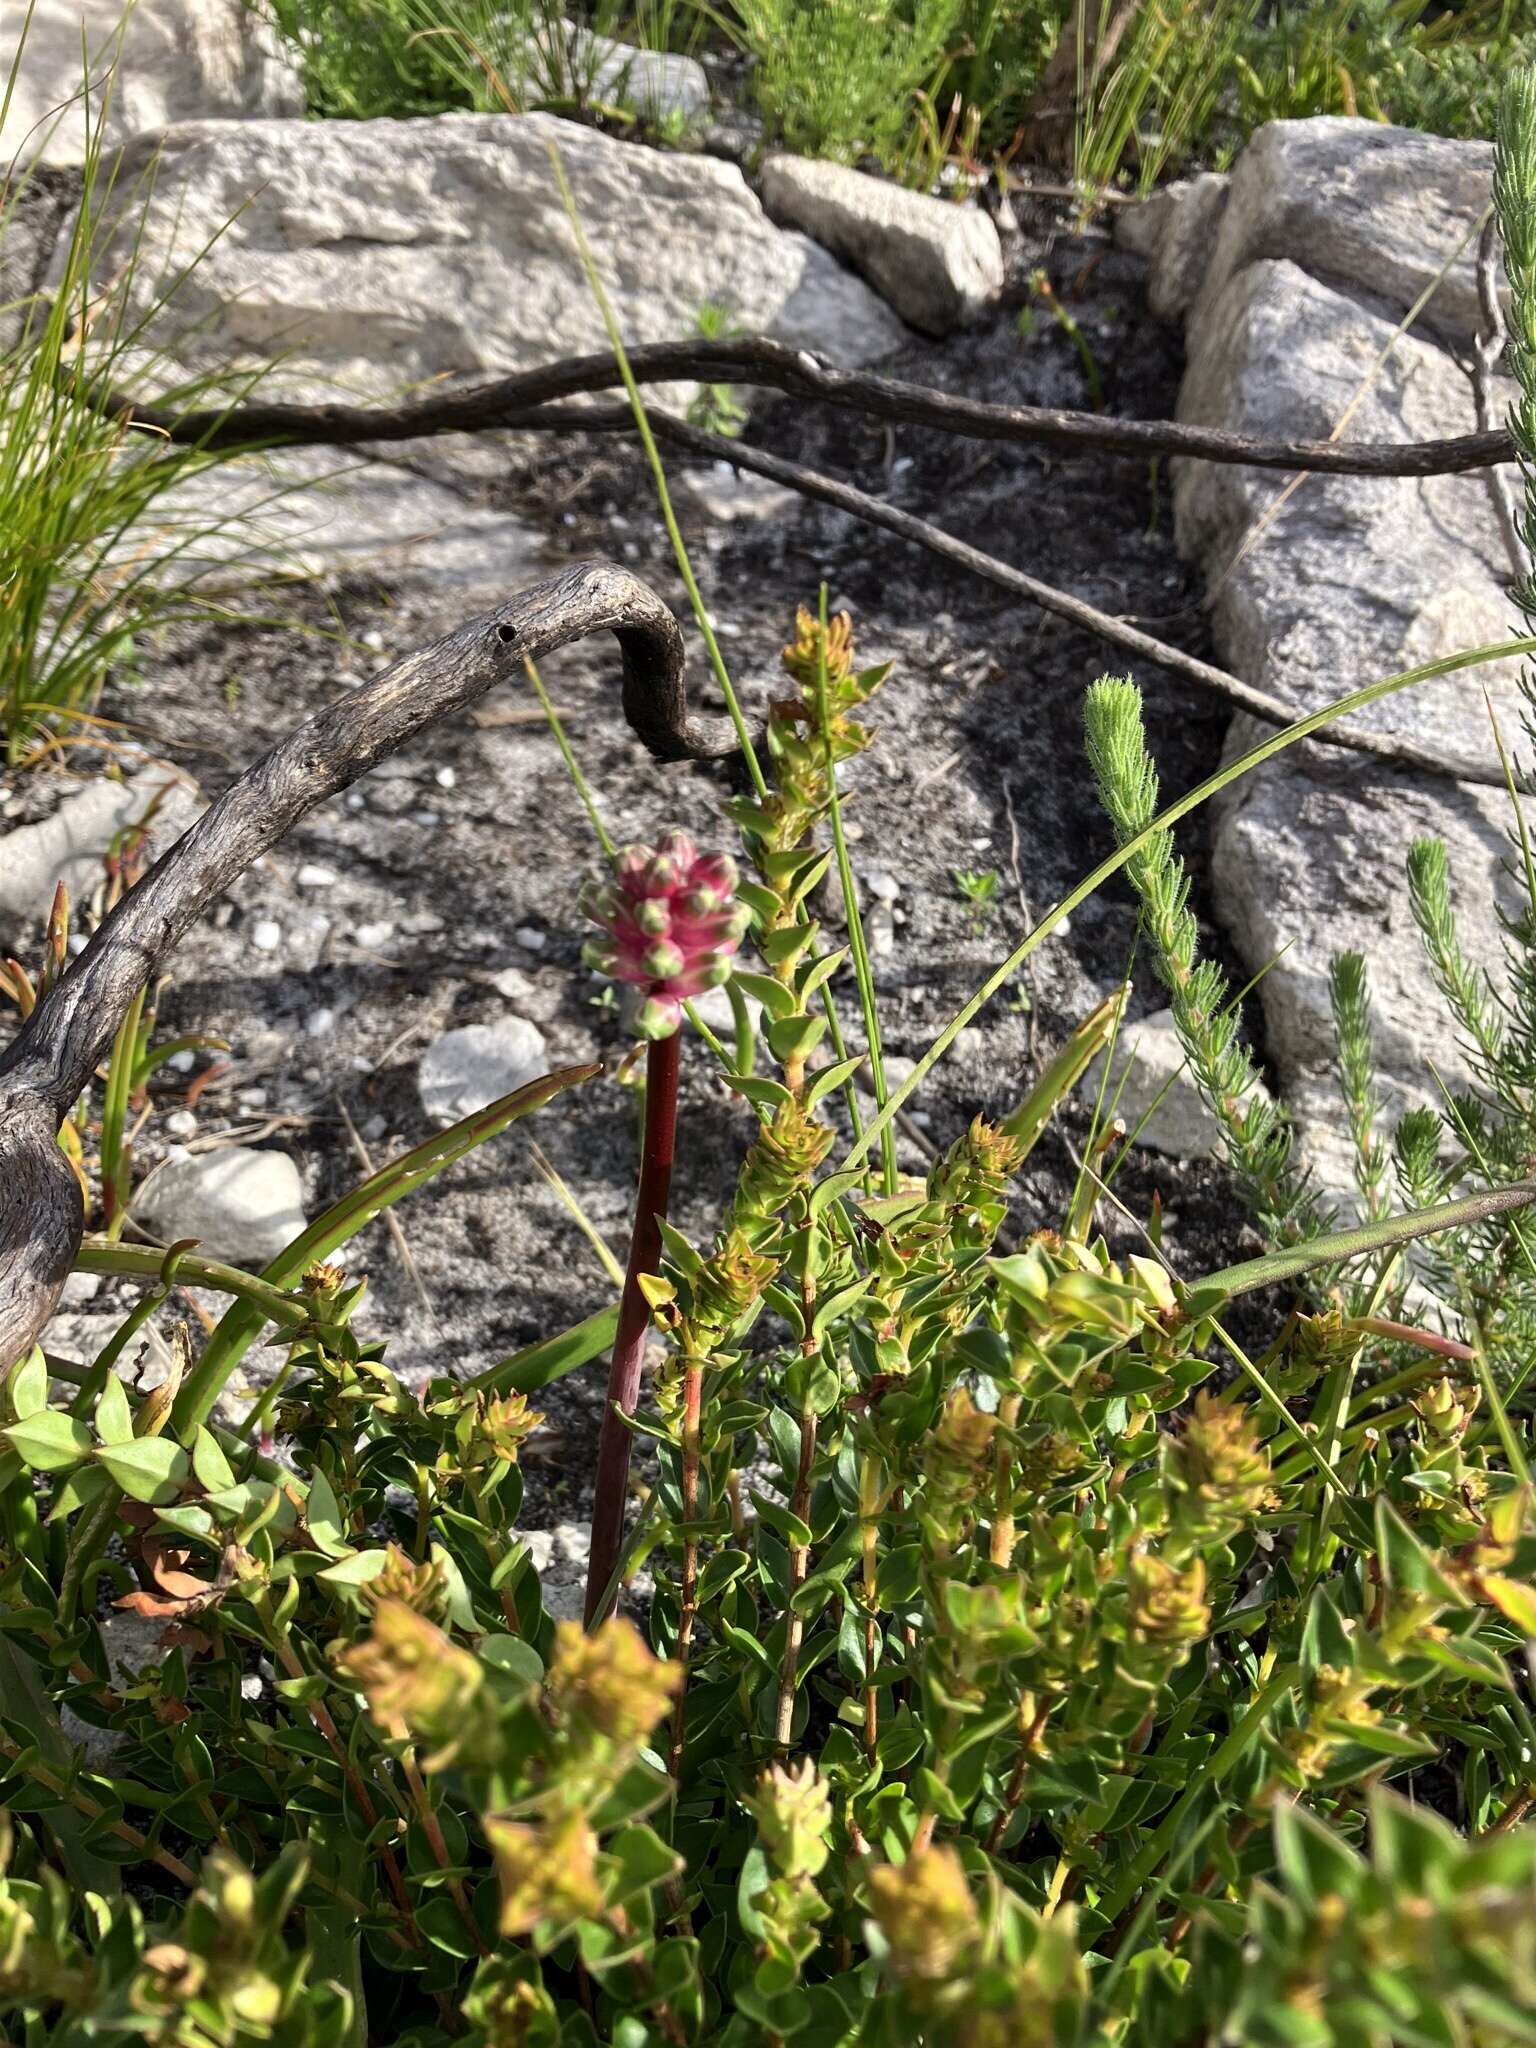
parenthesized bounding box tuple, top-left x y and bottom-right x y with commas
(27, 211, 1277, 1520)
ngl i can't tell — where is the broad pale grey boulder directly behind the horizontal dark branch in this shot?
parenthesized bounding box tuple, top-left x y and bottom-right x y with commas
(90, 115, 903, 395)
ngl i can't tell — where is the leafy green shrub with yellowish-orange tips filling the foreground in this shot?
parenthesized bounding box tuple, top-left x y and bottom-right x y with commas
(0, 589, 1536, 2048)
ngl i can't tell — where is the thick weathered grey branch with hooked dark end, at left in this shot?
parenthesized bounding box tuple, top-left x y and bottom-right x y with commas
(0, 561, 735, 1368)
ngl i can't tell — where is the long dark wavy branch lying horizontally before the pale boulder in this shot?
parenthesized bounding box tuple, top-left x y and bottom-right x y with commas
(117, 336, 1516, 477)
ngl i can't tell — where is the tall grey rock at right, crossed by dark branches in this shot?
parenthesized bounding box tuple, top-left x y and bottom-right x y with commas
(1174, 121, 1518, 1190)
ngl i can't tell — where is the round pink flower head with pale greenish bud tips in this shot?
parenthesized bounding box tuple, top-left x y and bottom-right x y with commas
(582, 831, 752, 1038)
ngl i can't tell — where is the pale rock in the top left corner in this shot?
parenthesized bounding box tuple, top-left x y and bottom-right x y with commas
(0, 0, 303, 166)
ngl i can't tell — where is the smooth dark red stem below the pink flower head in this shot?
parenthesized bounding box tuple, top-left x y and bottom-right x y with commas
(586, 1032, 682, 1628)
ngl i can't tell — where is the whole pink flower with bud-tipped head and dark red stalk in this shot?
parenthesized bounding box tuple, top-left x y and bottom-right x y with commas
(582, 831, 752, 1628)
